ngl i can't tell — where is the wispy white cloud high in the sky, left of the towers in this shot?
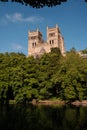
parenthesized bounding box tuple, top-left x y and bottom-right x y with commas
(5, 13, 43, 22)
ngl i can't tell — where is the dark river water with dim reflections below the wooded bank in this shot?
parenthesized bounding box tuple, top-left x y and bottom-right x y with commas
(0, 105, 87, 130)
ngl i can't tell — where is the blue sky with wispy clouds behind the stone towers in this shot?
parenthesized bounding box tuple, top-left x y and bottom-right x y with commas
(0, 0, 87, 55)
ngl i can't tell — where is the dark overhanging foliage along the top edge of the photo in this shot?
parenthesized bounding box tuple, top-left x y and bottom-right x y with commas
(0, 0, 87, 8)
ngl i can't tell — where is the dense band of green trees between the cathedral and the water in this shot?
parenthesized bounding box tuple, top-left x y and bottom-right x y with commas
(0, 48, 87, 103)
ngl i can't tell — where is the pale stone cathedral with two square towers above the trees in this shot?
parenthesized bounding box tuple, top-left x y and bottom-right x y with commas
(28, 25, 65, 58)
